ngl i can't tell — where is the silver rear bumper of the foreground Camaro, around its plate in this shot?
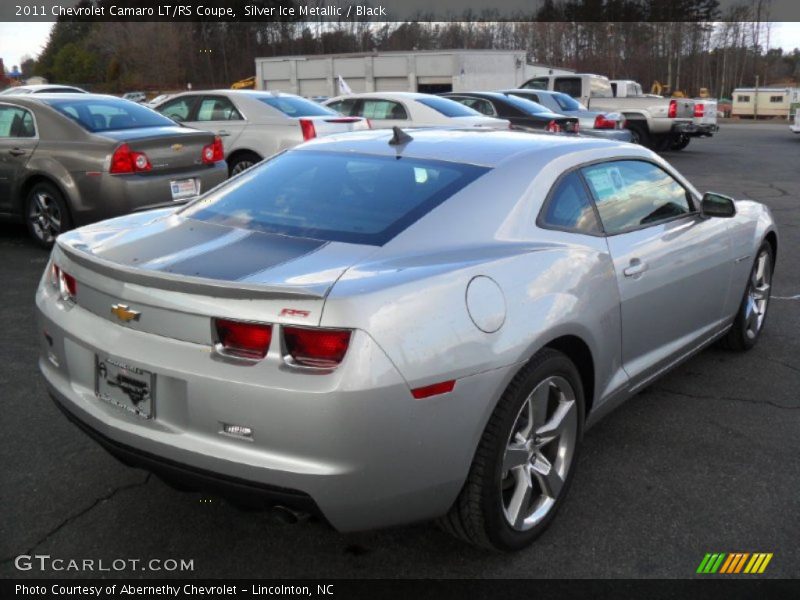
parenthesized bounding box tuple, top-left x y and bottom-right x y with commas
(36, 283, 514, 531)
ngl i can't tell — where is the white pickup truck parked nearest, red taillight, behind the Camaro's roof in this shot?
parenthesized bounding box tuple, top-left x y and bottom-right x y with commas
(520, 73, 697, 150)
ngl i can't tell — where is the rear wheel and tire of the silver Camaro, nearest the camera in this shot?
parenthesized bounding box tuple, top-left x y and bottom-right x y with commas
(438, 348, 584, 552)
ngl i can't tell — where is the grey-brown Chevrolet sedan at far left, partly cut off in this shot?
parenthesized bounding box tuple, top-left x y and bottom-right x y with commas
(0, 93, 227, 247)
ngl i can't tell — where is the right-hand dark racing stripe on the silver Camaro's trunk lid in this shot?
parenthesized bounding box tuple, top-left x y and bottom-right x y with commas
(159, 232, 327, 281)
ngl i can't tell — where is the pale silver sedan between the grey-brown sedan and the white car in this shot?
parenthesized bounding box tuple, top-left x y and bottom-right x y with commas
(154, 90, 369, 175)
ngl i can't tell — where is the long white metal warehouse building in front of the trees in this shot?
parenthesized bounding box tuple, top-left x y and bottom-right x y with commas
(256, 50, 572, 96)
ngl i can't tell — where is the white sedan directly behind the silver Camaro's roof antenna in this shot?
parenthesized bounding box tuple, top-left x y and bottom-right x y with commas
(323, 92, 510, 129)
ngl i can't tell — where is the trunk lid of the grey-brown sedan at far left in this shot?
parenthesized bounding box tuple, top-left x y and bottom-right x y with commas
(97, 126, 214, 174)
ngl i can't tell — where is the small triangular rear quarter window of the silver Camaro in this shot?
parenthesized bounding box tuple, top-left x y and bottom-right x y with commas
(539, 171, 601, 233)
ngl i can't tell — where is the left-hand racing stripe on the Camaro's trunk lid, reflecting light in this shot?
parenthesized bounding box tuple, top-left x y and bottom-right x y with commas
(97, 221, 233, 267)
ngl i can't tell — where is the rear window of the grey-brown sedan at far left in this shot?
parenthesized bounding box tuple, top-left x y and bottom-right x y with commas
(45, 94, 175, 133)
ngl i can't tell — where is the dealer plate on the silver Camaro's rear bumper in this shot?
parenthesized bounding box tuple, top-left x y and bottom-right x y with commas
(95, 356, 156, 419)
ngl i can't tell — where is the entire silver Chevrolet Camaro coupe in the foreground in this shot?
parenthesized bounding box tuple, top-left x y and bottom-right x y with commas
(36, 130, 778, 550)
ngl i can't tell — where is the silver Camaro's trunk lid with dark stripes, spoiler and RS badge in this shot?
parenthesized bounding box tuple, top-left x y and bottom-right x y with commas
(53, 209, 375, 336)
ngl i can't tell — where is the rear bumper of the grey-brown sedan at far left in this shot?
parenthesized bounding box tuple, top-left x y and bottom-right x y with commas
(71, 161, 228, 226)
